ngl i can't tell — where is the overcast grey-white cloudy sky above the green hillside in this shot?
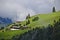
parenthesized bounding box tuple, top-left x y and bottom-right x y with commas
(0, 0, 60, 21)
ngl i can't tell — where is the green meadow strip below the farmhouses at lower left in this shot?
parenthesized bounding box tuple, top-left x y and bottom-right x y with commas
(0, 30, 27, 40)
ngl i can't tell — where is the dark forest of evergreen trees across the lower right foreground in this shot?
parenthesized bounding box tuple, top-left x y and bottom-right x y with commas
(12, 19, 60, 40)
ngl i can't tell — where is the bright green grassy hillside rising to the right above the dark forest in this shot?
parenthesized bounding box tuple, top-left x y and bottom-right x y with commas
(22, 12, 60, 28)
